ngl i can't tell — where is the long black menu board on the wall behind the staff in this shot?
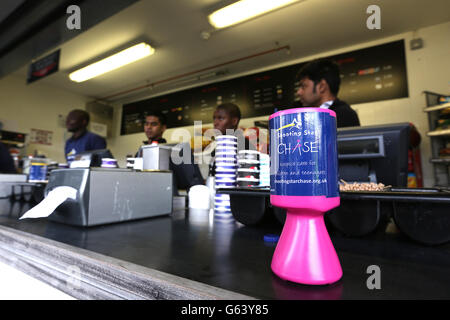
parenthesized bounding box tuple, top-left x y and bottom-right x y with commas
(121, 40, 408, 135)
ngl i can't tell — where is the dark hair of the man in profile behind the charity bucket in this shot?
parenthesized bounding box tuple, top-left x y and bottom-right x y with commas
(297, 59, 341, 96)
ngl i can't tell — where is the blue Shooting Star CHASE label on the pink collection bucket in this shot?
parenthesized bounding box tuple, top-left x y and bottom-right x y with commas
(269, 111, 339, 197)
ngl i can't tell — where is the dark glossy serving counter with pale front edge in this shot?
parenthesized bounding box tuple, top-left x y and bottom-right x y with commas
(0, 200, 450, 299)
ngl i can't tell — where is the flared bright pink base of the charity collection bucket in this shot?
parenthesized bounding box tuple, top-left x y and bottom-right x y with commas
(271, 209, 342, 285)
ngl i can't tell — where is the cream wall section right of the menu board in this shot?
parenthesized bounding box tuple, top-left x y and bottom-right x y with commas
(353, 23, 450, 187)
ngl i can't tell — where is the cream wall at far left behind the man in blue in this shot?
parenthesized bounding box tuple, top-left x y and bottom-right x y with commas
(0, 74, 88, 162)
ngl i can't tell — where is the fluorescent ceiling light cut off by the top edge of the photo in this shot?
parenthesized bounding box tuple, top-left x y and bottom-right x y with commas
(208, 0, 299, 29)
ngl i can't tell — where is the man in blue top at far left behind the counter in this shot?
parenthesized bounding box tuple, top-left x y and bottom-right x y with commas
(64, 109, 106, 160)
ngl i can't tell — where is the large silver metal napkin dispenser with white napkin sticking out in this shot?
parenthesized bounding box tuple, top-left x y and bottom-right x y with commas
(45, 168, 173, 226)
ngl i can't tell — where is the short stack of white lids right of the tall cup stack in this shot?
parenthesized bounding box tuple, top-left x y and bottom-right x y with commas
(237, 150, 260, 187)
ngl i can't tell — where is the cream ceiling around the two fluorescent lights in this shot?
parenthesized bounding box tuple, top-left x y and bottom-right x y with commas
(12, 0, 450, 101)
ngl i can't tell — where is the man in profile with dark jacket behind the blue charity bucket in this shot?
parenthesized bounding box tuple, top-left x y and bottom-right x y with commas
(297, 59, 360, 128)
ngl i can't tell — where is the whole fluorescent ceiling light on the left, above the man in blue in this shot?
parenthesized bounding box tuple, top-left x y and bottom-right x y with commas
(69, 42, 155, 82)
